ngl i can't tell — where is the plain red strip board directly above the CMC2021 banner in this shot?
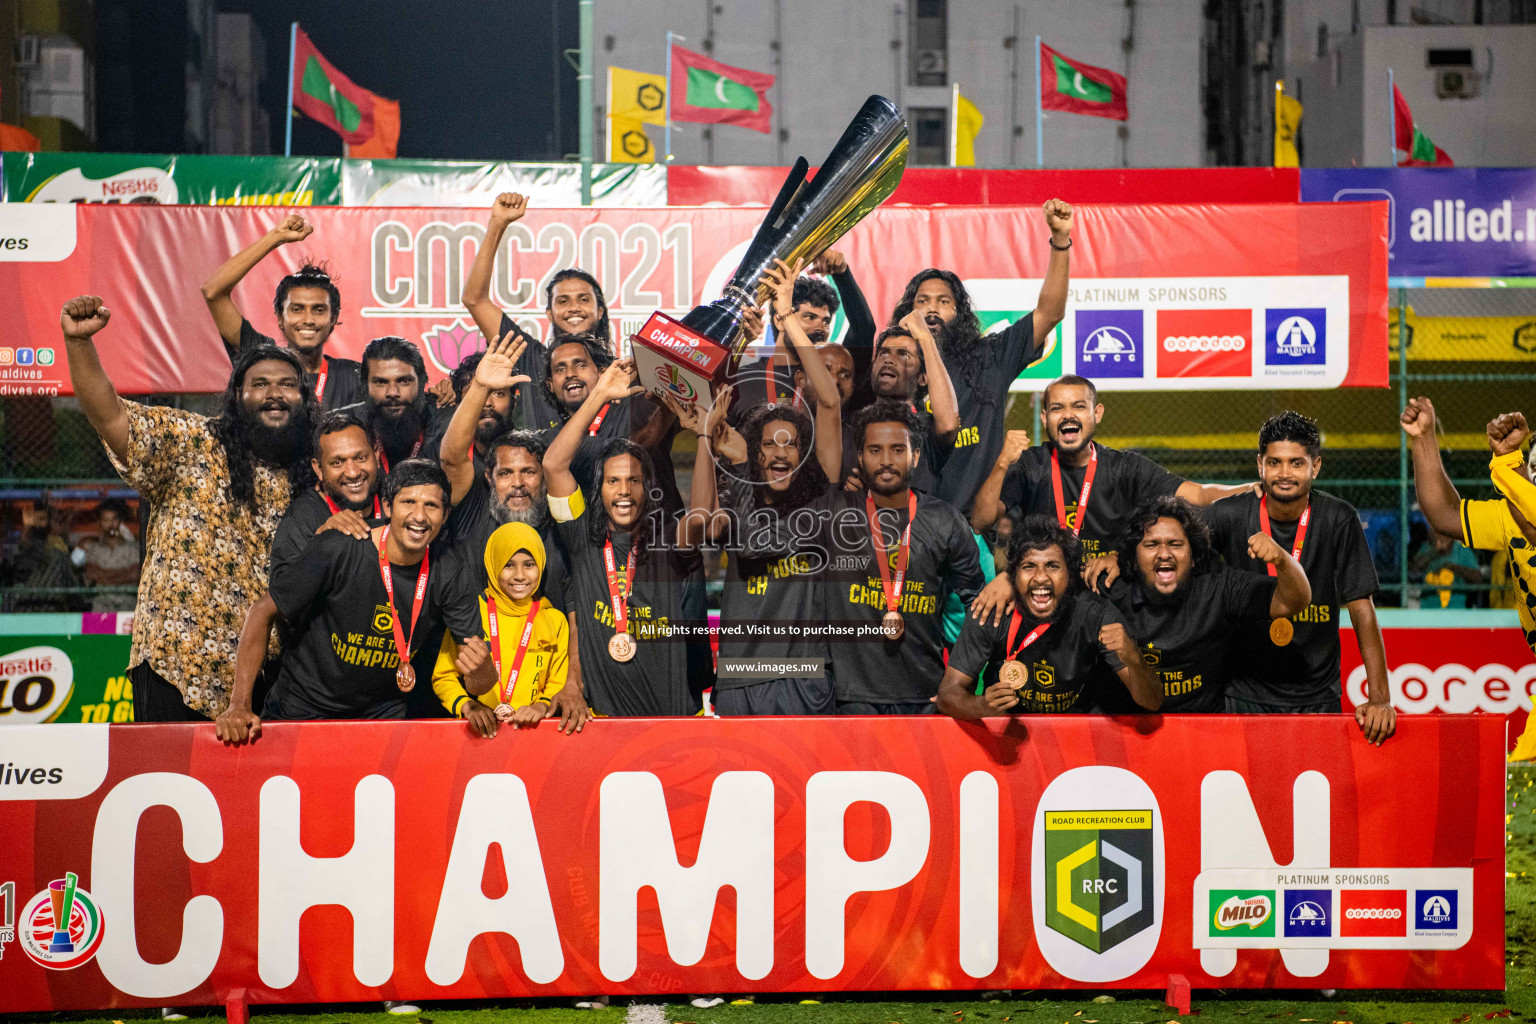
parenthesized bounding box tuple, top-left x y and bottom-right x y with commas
(667, 166, 1301, 206)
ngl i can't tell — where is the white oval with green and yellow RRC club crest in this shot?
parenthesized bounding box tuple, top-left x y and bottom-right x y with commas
(1032, 765, 1164, 981)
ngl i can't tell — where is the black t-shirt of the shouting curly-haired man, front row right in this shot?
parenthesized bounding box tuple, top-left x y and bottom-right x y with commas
(1103, 565, 1276, 714)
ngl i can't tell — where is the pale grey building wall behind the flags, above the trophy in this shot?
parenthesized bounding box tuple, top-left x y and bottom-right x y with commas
(594, 0, 1203, 167)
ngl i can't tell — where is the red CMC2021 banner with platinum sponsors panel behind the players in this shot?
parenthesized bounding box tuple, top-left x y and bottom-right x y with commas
(0, 203, 1387, 395)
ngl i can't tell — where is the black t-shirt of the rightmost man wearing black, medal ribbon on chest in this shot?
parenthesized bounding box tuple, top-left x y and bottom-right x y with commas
(1206, 488, 1378, 708)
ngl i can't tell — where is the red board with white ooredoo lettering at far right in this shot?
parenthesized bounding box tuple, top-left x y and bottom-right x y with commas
(1339, 626, 1536, 751)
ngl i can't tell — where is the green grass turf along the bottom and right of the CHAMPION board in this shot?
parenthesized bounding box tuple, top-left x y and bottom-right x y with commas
(12, 766, 1536, 1024)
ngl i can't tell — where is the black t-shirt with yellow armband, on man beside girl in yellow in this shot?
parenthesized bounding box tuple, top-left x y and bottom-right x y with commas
(556, 490, 707, 717)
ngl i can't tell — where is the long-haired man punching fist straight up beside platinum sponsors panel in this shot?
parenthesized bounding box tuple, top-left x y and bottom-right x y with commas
(891, 200, 1074, 516)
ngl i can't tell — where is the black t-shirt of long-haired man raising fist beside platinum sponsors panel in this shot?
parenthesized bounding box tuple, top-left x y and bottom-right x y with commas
(935, 313, 1040, 519)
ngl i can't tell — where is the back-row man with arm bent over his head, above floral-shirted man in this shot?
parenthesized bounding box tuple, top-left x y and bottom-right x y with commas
(203, 213, 362, 408)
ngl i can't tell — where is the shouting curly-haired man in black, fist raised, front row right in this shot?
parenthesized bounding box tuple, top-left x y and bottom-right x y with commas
(1101, 494, 1312, 712)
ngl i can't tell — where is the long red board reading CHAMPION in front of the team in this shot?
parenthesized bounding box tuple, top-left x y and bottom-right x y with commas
(0, 715, 1504, 1013)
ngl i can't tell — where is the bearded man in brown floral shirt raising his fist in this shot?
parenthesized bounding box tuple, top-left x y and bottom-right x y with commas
(60, 296, 316, 722)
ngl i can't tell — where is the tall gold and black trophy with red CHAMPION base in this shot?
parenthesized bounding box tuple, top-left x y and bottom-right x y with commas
(633, 97, 908, 402)
